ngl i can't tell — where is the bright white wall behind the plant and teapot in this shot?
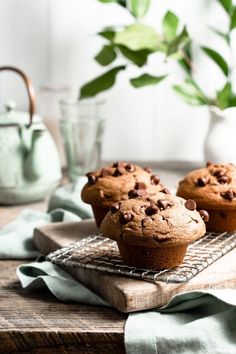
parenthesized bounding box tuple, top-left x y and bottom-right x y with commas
(0, 0, 234, 161)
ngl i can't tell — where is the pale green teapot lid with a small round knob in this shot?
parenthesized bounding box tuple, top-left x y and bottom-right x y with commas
(0, 100, 42, 126)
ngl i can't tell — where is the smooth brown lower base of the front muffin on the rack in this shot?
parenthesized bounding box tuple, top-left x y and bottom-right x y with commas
(117, 241, 187, 270)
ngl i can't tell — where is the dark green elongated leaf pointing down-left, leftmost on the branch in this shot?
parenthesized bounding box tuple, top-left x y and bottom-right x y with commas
(80, 65, 126, 99)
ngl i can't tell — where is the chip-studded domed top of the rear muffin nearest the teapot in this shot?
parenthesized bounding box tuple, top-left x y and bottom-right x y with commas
(81, 161, 164, 208)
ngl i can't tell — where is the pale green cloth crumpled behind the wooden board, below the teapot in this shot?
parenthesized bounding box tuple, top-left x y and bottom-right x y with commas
(0, 177, 92, 259)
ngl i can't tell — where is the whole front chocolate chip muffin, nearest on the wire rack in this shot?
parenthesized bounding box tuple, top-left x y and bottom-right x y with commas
(101, 192, 206, 270)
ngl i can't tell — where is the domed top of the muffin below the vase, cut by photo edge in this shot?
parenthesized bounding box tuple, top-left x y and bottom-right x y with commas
(177, 162, 236, 210)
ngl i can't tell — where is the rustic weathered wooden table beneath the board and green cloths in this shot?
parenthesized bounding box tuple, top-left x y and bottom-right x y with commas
(0, 165, 204, 354)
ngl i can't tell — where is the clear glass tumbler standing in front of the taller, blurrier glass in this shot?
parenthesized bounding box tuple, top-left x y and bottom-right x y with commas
(60, 98, 105, 181)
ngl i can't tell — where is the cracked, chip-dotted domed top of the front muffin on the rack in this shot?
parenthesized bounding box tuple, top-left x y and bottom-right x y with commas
(101, 192, 208, 247)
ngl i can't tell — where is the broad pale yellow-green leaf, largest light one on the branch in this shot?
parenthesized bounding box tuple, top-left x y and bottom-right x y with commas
(114, 23, 160, 52)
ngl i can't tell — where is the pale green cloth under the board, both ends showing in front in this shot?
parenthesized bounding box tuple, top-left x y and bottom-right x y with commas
(17, 261, 236, 354)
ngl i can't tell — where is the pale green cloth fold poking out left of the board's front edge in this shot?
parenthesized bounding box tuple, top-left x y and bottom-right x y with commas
(16, 261, 109, 306)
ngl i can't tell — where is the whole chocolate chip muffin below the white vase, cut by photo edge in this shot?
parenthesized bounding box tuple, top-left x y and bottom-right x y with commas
(177, 162, 236, 232)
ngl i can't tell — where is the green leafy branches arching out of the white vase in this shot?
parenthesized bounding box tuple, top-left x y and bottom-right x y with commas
(80, 0, 236, 109)
